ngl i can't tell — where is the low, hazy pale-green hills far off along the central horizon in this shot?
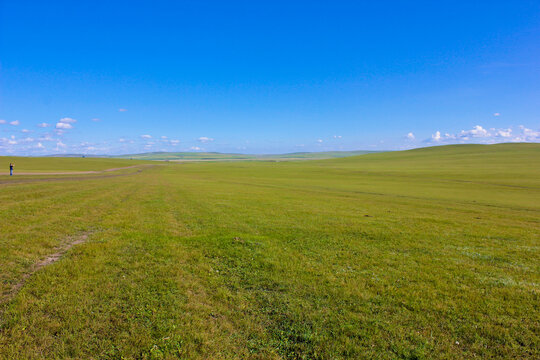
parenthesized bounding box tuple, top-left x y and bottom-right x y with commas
(113, 150, 376, 161)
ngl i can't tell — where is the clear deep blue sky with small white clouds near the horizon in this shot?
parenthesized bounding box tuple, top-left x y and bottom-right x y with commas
(0, 0, 540, 155)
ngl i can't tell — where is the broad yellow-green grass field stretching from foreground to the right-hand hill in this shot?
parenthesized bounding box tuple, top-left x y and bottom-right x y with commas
(0, 144, 540, 359)
